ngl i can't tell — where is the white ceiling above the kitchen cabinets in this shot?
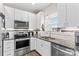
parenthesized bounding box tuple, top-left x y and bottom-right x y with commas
(4, 3, 52, 13)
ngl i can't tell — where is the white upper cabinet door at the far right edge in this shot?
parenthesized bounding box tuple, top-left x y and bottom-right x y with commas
(67, 3, 79, 27)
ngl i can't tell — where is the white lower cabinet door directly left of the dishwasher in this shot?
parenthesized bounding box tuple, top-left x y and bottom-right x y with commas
(40, 40, 51, 56)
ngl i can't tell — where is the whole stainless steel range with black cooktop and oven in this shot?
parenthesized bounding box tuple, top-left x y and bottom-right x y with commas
(14, 31, 30, 56)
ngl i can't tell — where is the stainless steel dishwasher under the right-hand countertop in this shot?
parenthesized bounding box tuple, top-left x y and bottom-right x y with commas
(51, 43, 74, 56)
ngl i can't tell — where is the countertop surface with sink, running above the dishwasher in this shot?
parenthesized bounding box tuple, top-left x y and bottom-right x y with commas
(31, 37, 75, 49)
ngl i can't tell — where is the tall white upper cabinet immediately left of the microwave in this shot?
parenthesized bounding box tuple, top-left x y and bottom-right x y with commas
(4, 6, 14, 29)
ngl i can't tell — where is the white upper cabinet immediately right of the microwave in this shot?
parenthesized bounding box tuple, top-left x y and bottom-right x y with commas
(28, 13, 37, 29)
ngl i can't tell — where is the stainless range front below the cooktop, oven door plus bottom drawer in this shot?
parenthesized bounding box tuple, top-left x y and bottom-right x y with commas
(15, 39, 30, 56)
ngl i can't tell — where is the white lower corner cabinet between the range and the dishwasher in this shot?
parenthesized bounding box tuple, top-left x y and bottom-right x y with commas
(30, 38, 51, 56)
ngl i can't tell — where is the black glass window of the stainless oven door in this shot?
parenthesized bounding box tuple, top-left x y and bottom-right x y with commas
(16, 39, 30, 49)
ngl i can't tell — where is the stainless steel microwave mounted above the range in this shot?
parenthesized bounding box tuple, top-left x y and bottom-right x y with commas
(14, 20, 29, 29)
